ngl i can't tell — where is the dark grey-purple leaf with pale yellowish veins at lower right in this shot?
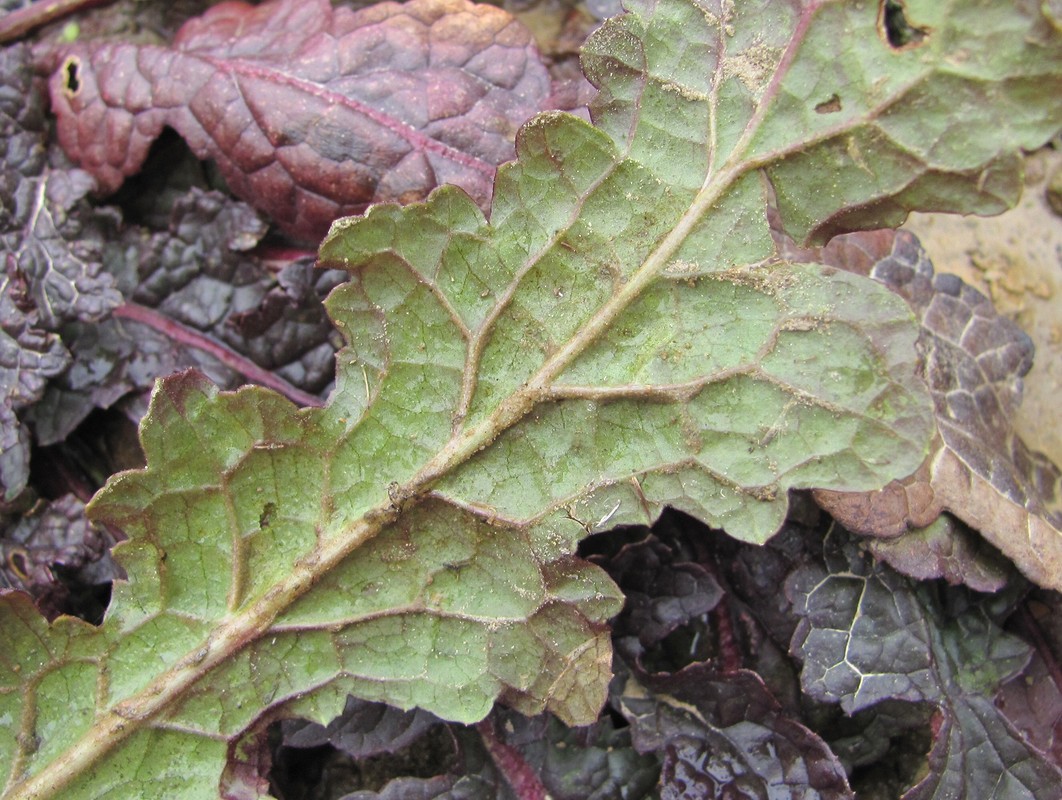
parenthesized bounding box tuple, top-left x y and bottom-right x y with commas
(787, 528, 1062, 800)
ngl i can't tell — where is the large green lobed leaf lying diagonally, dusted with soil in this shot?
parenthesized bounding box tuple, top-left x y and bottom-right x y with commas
(0, 0, 1060, 799)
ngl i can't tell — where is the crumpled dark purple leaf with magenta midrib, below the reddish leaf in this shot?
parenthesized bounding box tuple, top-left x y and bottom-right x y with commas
(31, 188, 339, 444)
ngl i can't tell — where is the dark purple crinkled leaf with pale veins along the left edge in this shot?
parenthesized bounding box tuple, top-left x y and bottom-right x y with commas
(0, 46, 115, 492)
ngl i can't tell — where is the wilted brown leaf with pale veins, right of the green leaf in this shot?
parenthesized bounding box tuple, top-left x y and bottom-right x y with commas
(778, 225, 1062, 590)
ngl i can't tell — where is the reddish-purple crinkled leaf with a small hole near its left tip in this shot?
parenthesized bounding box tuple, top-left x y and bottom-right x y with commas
(45, 0, 550, 241)
